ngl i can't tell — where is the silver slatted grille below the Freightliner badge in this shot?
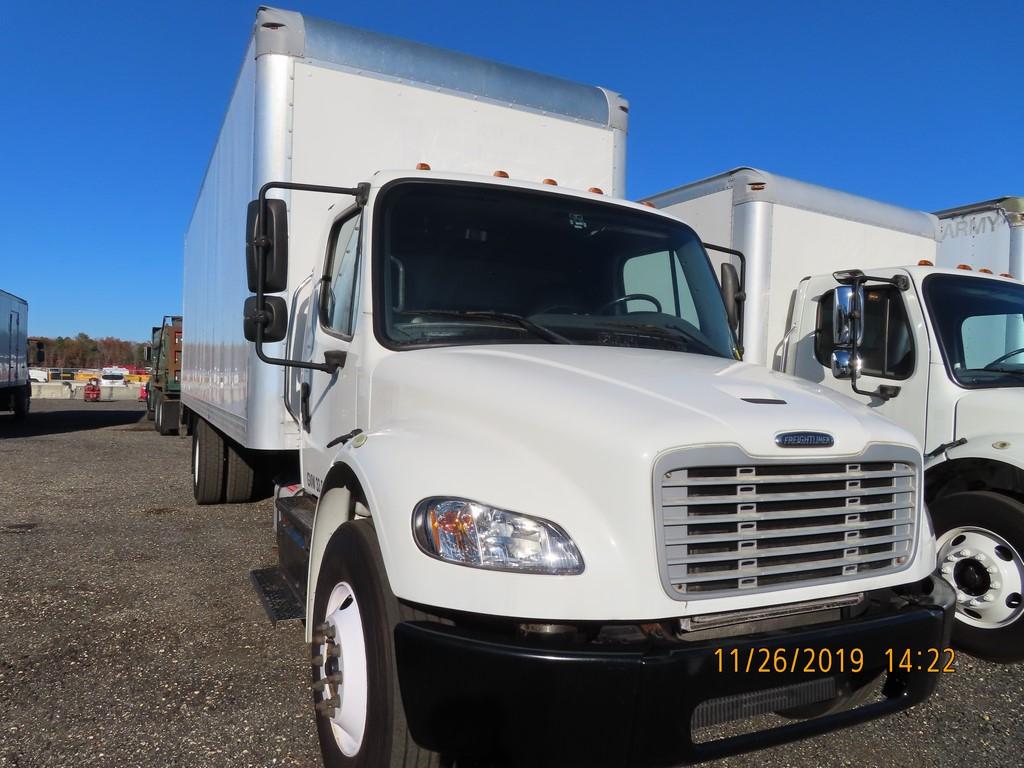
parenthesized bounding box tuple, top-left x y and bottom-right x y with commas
(655, 451, 916, 600)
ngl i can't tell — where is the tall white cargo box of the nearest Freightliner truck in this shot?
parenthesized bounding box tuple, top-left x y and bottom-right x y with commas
(181, 8, 629, 451)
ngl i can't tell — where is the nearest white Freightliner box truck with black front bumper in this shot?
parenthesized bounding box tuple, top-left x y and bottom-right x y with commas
(188, 9, 953, 766)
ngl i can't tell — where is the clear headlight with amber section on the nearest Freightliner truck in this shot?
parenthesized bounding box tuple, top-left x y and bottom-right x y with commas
(413, 498, 583, 574)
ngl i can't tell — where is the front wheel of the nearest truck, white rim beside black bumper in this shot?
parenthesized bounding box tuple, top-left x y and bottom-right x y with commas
(311, 520, 439, 768)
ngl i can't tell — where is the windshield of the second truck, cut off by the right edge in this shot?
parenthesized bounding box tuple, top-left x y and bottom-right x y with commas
(924, 274, 1024, 388)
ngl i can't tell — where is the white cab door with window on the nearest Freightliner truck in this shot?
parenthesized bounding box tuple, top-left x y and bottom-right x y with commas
(290, 207, 369, 495)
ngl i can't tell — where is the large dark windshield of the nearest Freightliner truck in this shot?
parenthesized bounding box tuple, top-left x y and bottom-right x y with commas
(377, 182, 735, 357)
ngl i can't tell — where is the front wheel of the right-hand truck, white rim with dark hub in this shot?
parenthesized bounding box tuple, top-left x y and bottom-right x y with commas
(931, 490, 1024, 663)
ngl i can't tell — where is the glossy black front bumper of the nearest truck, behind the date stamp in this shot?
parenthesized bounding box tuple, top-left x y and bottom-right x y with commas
(395, 579, 953, 767)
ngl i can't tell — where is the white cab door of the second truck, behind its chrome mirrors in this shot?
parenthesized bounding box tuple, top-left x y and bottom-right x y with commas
(785, 269, 930, 444)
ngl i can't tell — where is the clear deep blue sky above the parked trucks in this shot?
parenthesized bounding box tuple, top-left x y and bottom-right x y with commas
(0, 0, 1024, 339)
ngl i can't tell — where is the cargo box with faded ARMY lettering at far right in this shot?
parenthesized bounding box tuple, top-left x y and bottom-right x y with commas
(935, 197, 1024, 279)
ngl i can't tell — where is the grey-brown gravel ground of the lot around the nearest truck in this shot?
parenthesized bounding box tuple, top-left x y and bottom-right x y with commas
(0, 400, 1024, 768)
